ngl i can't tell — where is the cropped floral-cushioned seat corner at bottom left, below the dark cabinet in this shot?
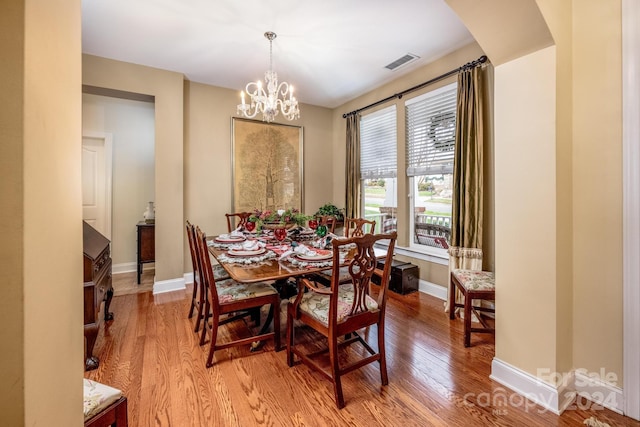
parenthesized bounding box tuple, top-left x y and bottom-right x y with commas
(84, 378, 127, 427)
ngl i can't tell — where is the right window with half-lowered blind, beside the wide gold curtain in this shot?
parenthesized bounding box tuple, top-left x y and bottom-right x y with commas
(405, 83, 457, 255)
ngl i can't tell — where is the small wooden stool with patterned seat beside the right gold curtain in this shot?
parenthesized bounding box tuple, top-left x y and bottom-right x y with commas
(449, 270, 496, 347)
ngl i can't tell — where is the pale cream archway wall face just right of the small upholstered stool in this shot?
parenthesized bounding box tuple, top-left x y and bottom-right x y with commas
(495, 47, 556, 374)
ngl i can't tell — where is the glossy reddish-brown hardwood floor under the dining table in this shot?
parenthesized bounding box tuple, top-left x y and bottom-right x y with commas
(86, 273, 640, 427)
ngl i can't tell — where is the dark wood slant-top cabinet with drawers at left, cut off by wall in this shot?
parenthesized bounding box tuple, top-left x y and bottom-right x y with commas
(82, 221, 113, 371)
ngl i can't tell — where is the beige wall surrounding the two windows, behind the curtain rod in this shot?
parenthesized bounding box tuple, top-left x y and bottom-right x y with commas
(333, 43, 494, 287)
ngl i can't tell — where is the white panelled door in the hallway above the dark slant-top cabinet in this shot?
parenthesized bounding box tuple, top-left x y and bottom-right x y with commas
(82, 133, 112, 240)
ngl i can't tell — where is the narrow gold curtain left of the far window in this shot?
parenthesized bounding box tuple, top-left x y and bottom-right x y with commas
(345, 114, 361, 218)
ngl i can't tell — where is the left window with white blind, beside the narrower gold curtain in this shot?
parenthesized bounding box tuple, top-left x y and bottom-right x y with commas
(360, 105, 398, 233)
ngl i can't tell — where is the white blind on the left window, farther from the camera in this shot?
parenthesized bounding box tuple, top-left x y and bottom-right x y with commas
(360, 105, 397, 179)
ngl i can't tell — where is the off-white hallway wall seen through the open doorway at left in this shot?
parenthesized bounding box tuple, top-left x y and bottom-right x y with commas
(82, 94, 155, 272)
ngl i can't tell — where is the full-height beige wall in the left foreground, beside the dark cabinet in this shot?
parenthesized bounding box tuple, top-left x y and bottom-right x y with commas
(0, 0, 84, 426)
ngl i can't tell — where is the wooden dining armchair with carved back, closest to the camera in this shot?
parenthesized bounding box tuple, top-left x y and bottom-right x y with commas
(287, 232, 397, 408)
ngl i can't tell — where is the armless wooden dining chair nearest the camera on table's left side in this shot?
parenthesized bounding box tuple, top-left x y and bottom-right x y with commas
(196, 227, 280, 368)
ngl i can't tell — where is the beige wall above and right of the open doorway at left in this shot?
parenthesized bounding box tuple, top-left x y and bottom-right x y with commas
(82, 55, 184, 281)
